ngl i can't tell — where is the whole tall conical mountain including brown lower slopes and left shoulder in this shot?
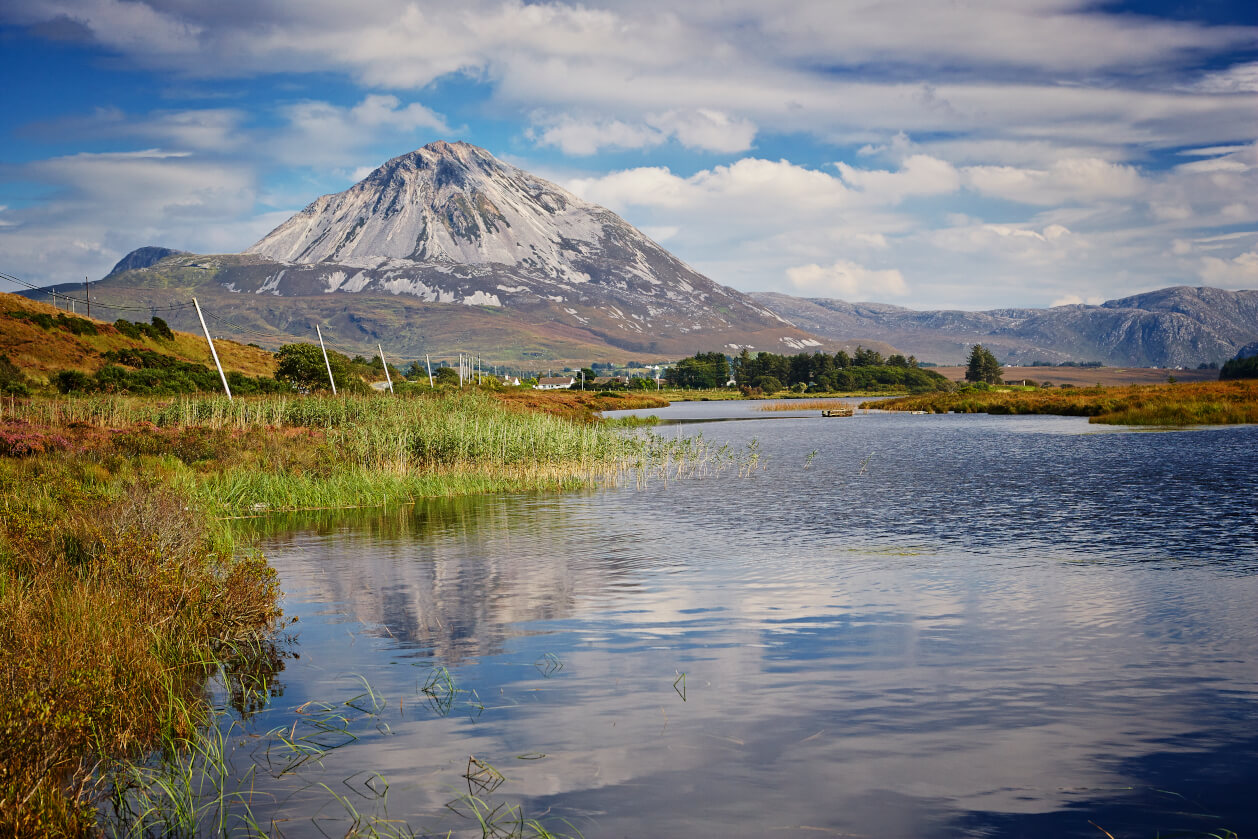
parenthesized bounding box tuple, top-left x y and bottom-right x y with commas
(78, 142, 870, 361)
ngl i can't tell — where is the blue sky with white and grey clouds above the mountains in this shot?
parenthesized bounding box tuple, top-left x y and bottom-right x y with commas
(0, 0, 1258, 309)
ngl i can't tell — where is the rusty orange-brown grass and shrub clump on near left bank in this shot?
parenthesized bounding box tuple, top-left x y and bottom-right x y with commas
(0, 452, 279, 836)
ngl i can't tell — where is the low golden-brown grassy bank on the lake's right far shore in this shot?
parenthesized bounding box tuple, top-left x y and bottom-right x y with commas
(862, 381, 1258, 426)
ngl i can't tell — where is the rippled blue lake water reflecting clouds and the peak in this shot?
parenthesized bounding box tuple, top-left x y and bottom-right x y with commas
(233, 403, 1258, 839)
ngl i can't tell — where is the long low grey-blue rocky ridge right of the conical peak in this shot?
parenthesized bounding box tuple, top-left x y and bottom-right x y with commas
(752, 286, 1258, 367)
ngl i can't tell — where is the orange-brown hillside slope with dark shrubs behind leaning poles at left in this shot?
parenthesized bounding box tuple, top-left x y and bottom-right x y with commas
(0, 293, 276, 382)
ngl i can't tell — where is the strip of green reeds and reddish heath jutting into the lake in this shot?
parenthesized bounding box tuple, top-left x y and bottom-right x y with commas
(0, 392, 735, 514)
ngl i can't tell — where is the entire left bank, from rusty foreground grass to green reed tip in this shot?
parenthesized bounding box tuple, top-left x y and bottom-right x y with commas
(0, 392, 736, 836)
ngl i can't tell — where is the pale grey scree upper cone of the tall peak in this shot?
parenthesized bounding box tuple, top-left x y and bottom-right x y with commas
(245, 142, 808, 337)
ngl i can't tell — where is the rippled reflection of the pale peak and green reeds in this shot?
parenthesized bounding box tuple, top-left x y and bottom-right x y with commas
(257, 496, 639, 664)
